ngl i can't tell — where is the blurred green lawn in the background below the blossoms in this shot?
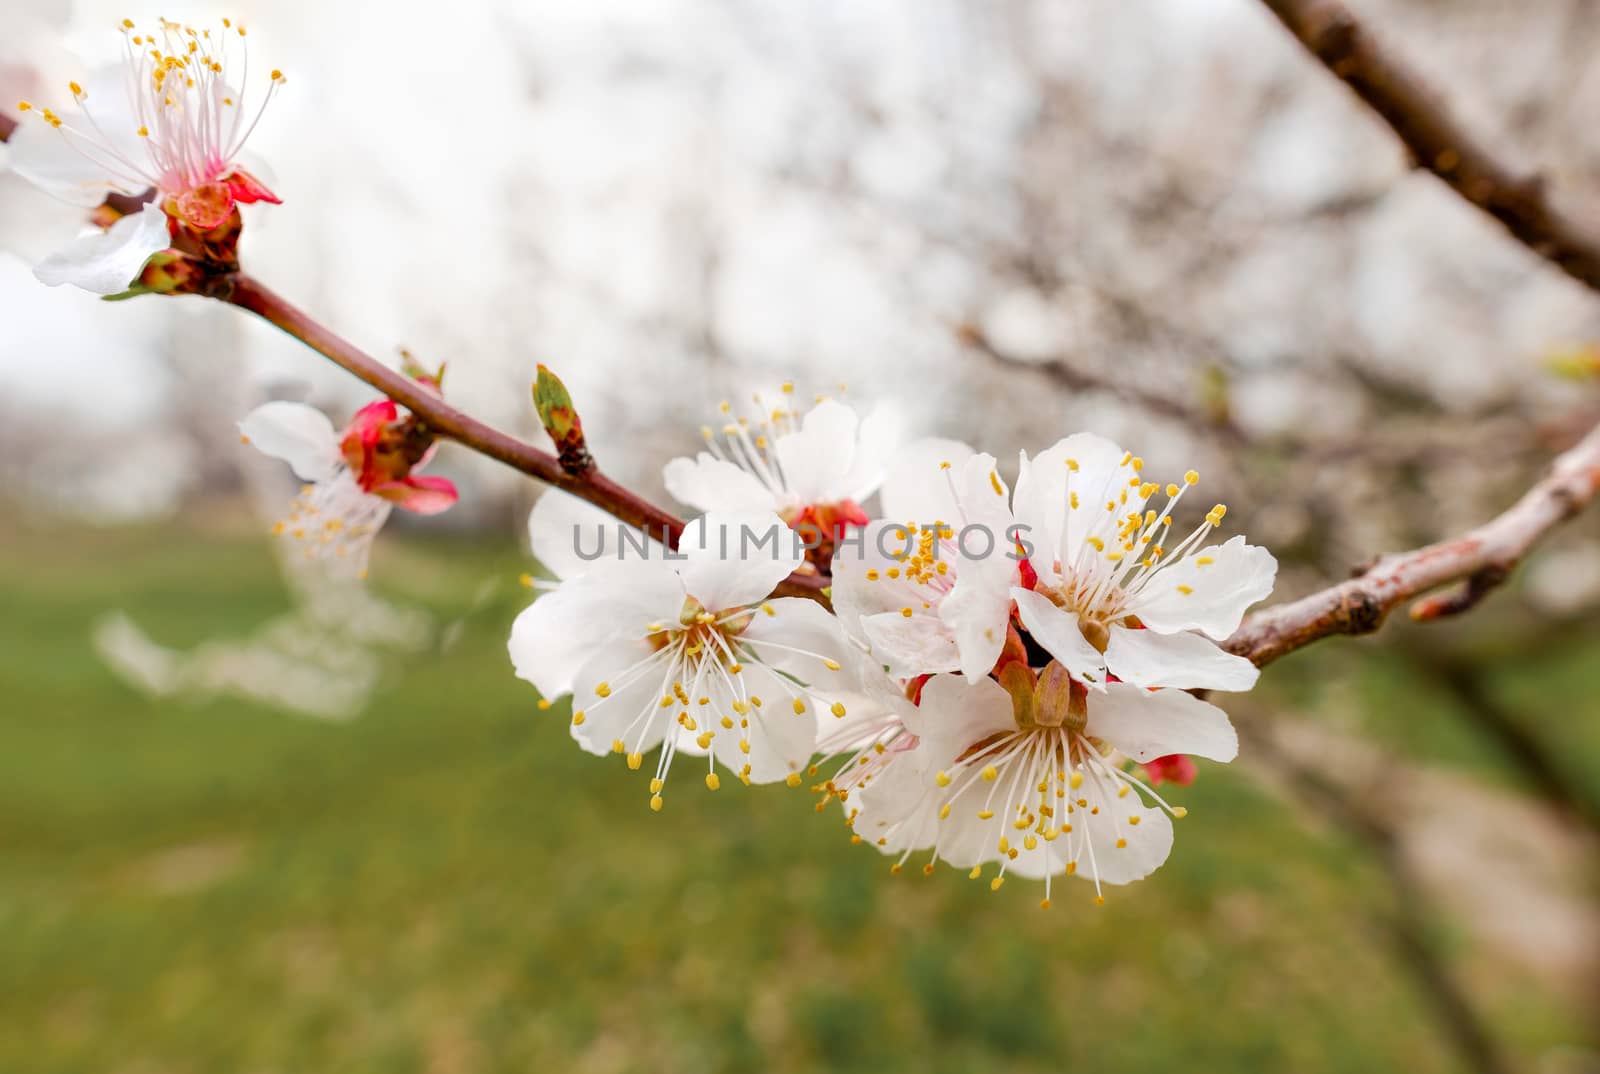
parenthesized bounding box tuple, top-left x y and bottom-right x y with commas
(0, 527, 1580, 1074)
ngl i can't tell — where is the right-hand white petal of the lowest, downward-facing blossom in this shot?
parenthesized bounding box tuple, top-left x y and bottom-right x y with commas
(1086, 682, 1238, 762)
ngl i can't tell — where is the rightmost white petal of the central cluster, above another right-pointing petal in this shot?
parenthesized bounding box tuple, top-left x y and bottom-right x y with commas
(1128, 536, 1278, 640)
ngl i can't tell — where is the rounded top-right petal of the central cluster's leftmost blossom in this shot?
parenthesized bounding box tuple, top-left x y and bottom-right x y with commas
(672, 511, 805, 611)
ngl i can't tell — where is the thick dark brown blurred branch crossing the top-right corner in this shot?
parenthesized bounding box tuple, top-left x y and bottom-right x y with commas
(1261, 0, 1600, 291)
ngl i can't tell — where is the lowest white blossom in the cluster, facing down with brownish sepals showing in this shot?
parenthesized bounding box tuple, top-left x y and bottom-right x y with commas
(851, 661, 1238, 906)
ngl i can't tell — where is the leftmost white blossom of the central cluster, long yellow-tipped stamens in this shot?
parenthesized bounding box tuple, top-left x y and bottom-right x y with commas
(509, 491, 851, 810)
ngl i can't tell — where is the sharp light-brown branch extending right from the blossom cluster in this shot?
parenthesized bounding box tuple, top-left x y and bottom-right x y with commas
(1224, 426, 1600, 666)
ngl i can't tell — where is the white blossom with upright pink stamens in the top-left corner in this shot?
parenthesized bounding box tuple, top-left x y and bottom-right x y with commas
(10, 19, 283, 295)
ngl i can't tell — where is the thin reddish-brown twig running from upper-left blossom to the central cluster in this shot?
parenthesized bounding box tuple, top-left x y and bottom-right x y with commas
(221, 274, 827, 600)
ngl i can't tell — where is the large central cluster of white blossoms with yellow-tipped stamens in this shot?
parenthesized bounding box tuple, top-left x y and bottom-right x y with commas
(510, 386, 1277, 904)
